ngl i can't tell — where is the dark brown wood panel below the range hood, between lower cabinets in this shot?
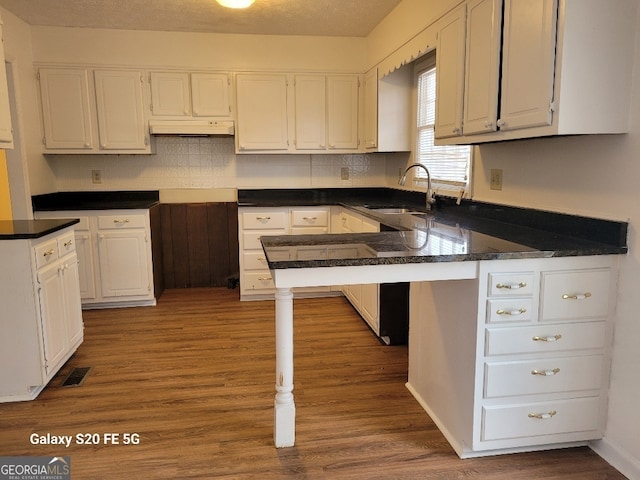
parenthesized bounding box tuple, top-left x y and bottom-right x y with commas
(160, 202, 240, 288)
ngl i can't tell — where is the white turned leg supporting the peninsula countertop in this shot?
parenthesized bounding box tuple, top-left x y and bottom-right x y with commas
(273, 288, 296, 448)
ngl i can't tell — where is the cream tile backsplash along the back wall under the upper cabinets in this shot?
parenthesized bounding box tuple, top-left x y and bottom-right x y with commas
(52, 136, 386, 191)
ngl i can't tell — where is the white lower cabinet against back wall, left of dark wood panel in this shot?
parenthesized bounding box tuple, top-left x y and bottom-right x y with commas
(36, 210, 155, 308)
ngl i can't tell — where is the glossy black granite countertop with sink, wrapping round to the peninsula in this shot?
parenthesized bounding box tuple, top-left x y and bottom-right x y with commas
(238, 189, 628, 269)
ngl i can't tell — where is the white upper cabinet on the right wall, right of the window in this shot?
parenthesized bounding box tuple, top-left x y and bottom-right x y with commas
(436, 0, 635, 144)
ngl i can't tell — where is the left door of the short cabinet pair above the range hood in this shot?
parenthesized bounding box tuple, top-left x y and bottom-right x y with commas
(149, 72, 191, 117)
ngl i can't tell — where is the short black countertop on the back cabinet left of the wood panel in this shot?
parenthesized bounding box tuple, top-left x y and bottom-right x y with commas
(31, 190, 160, 211)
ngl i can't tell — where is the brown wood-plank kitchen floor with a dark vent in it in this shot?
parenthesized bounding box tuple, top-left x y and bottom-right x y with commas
(0, 288, 625, 480)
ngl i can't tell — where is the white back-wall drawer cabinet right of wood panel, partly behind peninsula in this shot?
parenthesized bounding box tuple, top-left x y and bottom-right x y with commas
(238, 206, 330, 300)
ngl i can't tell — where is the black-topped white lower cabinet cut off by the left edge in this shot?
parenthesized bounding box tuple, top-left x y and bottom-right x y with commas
(0, 227, 84, 402)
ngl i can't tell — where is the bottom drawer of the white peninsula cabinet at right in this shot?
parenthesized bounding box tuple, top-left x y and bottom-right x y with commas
(482, 397, 600, 440)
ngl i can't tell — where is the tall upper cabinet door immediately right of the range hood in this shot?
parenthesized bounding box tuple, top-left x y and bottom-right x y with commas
(236, 74, 289, 152)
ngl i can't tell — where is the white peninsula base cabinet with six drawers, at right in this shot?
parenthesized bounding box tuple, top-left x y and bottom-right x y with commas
(407, 256, 618, 458)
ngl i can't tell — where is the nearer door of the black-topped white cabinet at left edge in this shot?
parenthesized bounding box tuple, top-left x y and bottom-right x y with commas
(37, 262, 67, 375)
